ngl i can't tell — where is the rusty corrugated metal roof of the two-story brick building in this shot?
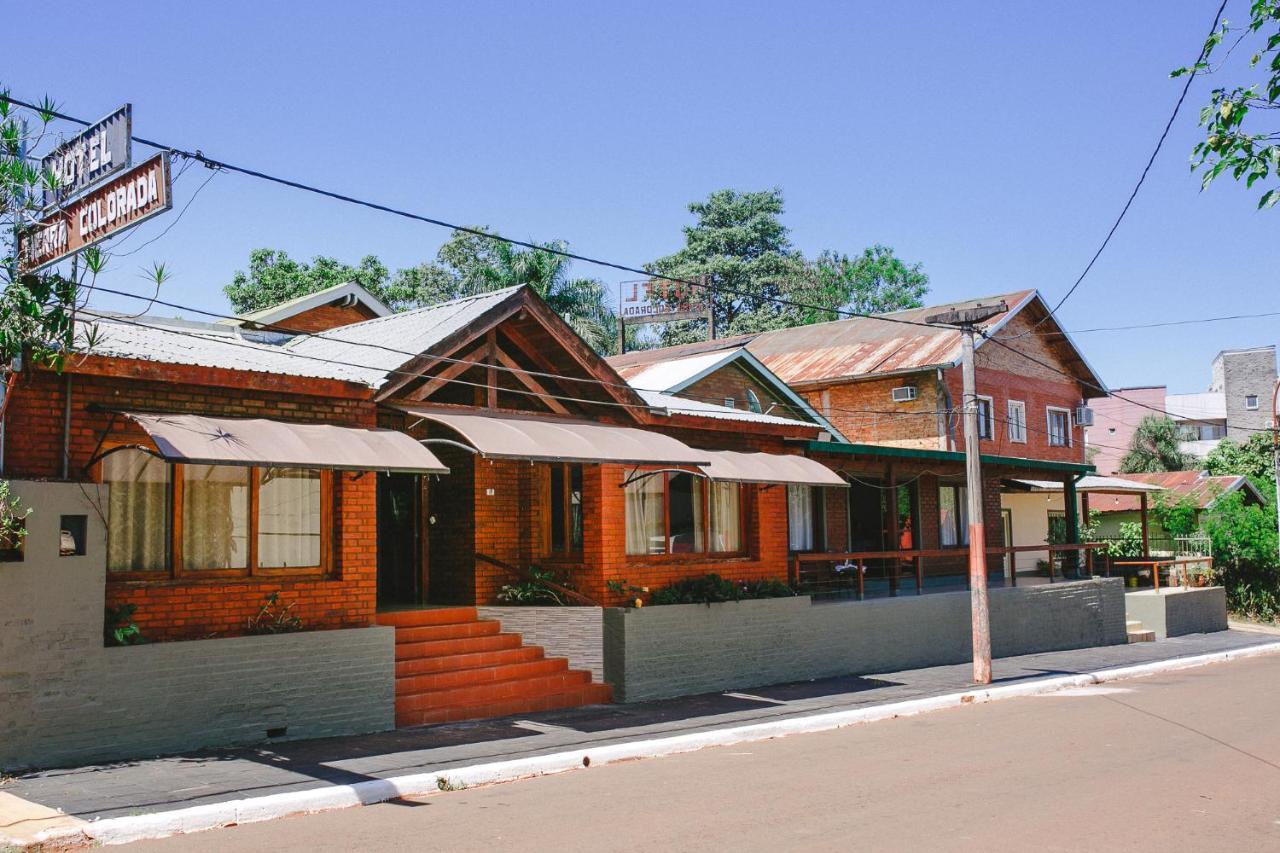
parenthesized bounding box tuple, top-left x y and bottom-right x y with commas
(746, 291, 1036, 384)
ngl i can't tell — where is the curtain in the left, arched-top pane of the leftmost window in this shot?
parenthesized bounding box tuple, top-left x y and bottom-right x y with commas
(102, 450, 169, 571)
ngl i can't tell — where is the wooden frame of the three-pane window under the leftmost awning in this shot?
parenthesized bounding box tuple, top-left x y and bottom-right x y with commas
(93, 451, 335, 583)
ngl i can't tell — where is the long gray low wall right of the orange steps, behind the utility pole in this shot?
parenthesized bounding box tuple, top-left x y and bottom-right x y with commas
(604, 578, 1126, 702)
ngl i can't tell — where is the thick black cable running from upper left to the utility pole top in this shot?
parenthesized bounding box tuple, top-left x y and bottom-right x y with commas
(0, 93, 952, 328)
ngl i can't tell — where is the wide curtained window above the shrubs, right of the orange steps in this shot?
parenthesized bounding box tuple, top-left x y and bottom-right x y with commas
(625, 471, 745, 556)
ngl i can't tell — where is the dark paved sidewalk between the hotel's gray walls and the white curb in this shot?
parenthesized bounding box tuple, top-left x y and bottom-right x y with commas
(0, 630, 1277, 820)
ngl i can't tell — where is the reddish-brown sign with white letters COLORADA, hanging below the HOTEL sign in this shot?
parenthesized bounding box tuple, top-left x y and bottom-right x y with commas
(18, 154, 173, 273)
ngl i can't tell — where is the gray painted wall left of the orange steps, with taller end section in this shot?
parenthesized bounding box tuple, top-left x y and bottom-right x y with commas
(0, 482, 394, 768)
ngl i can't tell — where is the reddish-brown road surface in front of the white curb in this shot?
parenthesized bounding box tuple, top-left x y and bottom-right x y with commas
(129, 656, 1280, 853)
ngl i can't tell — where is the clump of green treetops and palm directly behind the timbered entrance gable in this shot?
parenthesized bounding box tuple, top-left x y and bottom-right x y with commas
(392, 229, 618, 353)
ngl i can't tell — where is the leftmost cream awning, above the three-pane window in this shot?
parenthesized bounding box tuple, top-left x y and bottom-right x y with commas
(122, 412, 449, 474)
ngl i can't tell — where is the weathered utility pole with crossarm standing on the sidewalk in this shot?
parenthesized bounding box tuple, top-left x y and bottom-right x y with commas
(924, 302, 1009, 684)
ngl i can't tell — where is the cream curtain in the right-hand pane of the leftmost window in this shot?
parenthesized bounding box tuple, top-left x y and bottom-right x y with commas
(257, 467, 320, 569)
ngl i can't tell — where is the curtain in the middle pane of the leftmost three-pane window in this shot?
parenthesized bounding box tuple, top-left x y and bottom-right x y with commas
(182, 465, 250, 571)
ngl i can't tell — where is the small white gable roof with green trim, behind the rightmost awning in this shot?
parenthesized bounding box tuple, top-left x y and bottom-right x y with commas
(605, 346, 847, 442)
